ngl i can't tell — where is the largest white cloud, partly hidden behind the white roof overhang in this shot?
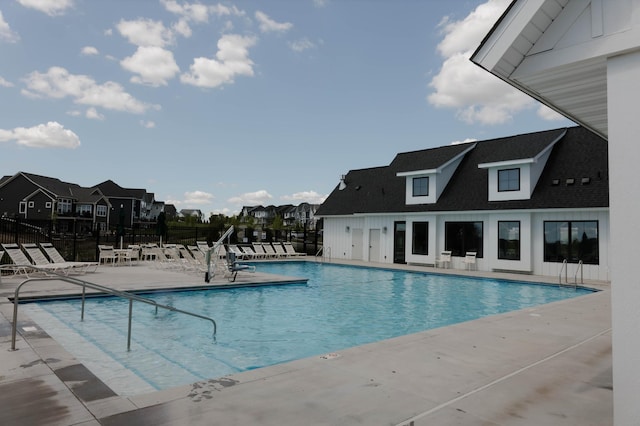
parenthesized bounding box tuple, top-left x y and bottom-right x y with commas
(428, 0, 535, 124)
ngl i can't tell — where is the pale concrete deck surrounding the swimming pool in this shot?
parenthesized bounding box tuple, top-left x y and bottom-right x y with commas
(0, 262, 613, 426)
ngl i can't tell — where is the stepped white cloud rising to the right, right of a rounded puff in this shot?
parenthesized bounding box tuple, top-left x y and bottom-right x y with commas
(180, 34, 257, 88)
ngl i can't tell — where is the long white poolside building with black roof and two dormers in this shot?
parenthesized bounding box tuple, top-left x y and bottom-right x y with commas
(316, 127, 610, 280)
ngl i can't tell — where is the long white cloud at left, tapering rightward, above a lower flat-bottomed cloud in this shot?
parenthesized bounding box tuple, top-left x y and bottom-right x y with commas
(22, 67, 158, 114)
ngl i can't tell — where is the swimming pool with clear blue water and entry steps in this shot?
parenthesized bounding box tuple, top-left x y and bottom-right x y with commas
(24, 262, 589, 395)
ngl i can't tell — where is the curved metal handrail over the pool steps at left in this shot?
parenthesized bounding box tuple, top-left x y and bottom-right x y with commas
(0, 264, 218, 351)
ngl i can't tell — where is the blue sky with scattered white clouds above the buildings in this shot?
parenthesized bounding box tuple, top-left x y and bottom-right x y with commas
(0, 0, 574, 218)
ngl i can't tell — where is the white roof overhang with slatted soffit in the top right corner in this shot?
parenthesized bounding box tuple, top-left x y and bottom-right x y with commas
(471, 0, 620, 139)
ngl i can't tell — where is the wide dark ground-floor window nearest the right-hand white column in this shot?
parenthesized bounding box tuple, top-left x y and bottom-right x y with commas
(544, 220, 600, 265)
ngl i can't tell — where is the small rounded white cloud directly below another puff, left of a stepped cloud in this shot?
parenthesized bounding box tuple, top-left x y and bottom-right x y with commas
(120, 46, 180, 87)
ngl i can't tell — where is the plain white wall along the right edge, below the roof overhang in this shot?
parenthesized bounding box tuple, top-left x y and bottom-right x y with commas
(607, 49, 640, 426)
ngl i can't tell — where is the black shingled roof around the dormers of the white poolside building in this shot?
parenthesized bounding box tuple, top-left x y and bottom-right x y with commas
(316, 127, 609, 216)
